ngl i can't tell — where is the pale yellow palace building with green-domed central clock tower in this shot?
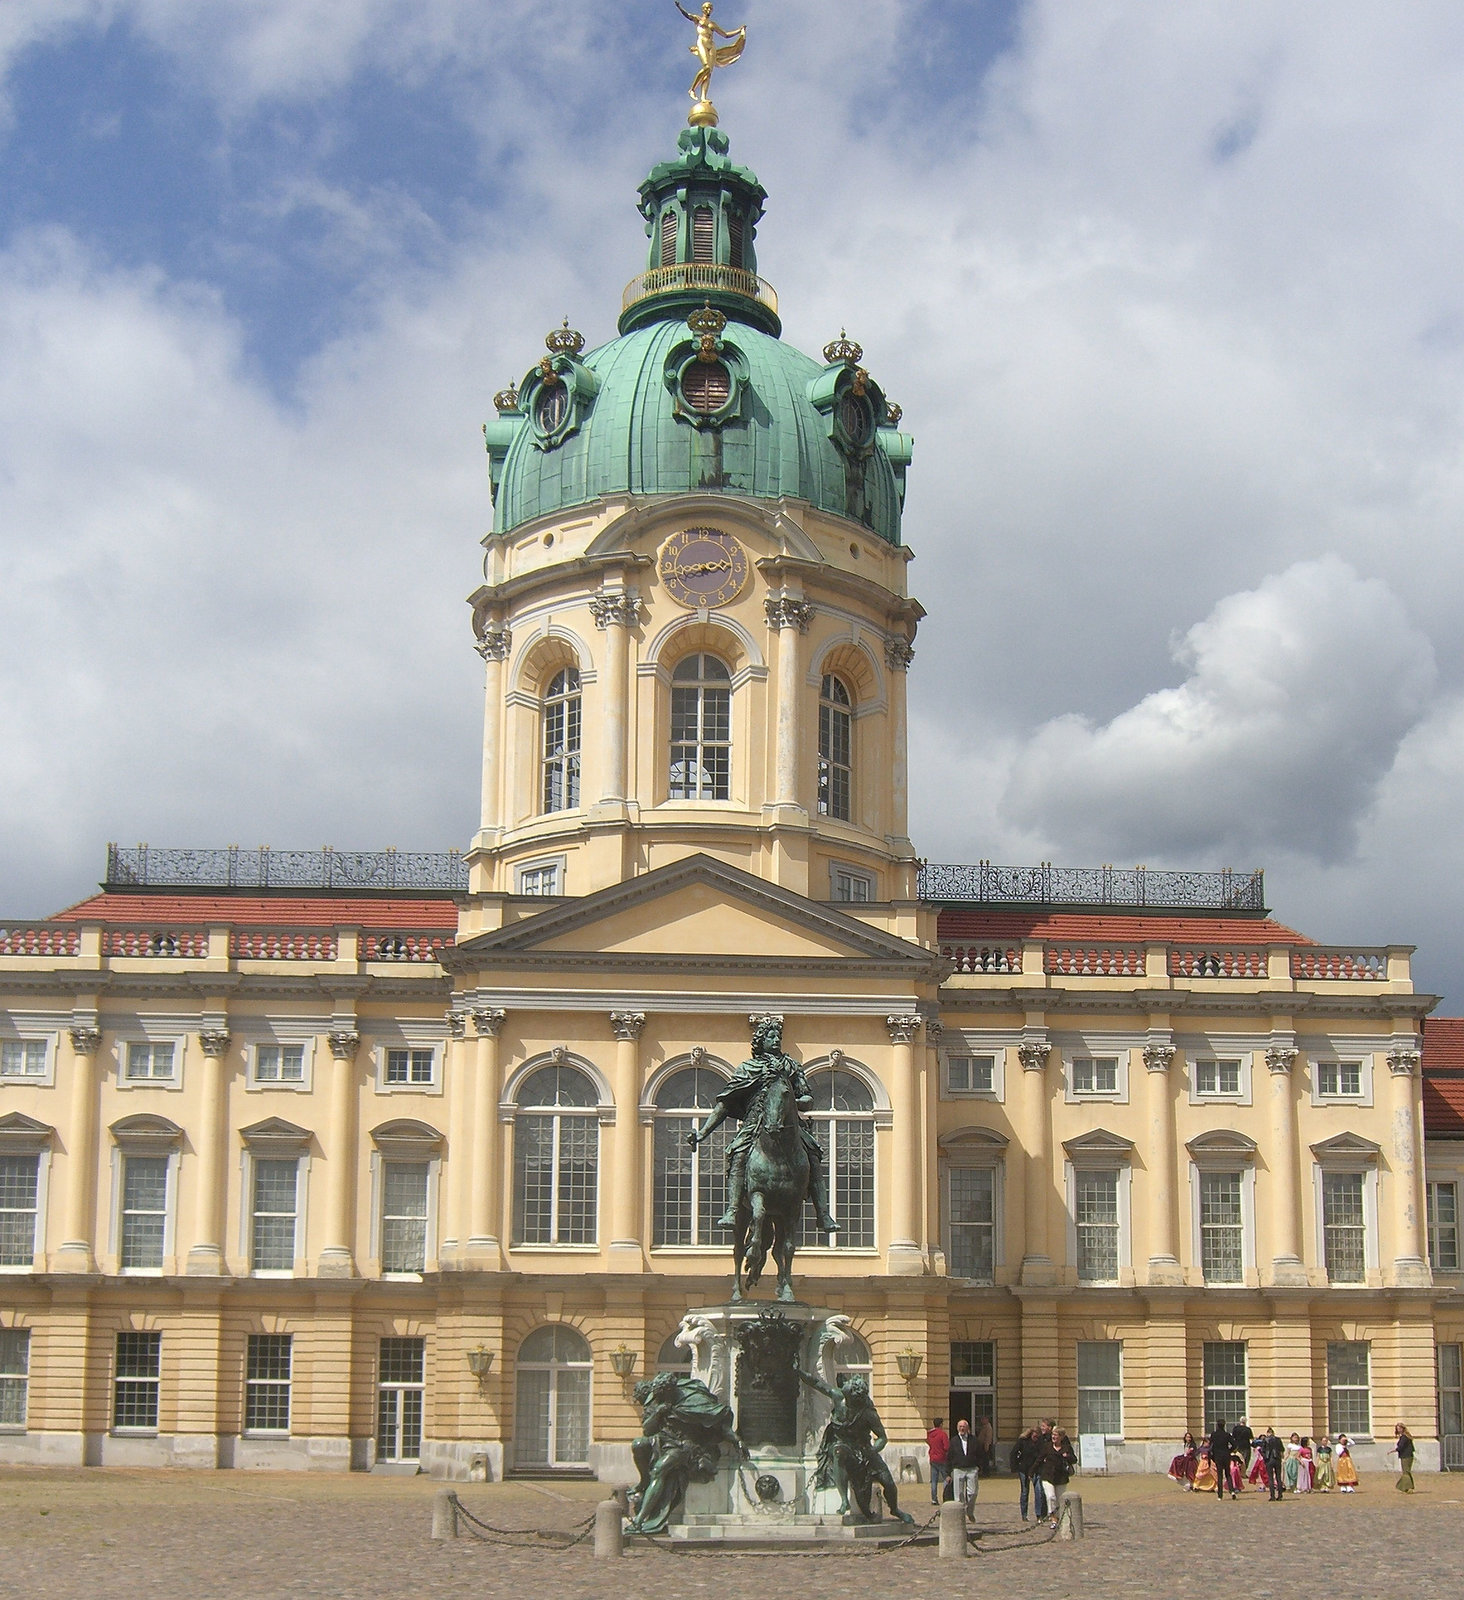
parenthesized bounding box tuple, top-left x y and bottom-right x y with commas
(0, 116, 1464, 1480)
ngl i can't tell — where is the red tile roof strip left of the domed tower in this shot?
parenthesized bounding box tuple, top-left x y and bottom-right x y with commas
(51, 893, 458, 933)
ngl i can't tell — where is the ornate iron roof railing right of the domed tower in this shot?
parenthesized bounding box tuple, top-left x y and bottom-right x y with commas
(918, 861, 1266, 912)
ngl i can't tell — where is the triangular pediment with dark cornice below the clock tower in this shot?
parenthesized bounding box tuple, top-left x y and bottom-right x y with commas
(450, 854, 939, 978)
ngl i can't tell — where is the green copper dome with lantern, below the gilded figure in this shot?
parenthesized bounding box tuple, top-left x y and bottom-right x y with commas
(483, 128, 912, 544)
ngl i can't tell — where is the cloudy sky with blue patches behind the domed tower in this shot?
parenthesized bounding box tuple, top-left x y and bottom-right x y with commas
(0, 0, 1464, 1011)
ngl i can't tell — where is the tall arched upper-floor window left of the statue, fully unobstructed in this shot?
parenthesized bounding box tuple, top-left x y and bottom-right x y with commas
(514, 1066, 600, 1245)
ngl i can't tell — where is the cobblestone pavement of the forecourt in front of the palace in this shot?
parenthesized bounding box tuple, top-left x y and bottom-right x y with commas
(0, 1469, 1464, 1600)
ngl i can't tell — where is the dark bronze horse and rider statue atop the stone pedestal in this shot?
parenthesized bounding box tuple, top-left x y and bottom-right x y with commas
(686, 1016, 838, 1301)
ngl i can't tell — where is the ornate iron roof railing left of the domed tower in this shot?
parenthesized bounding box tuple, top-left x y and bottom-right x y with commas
(104, 845, 467, 893)
